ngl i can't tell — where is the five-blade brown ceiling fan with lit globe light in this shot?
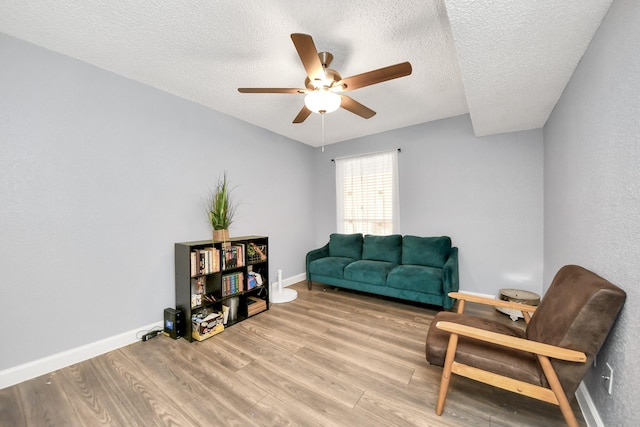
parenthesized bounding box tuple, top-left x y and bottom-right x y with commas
(238, 33, 411, 123)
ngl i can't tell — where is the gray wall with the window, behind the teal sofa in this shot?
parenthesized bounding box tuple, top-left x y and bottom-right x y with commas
(314, 115, 543, 295)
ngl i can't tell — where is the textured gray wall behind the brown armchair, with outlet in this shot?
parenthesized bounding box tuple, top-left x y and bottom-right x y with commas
(544, 0, 640, 426)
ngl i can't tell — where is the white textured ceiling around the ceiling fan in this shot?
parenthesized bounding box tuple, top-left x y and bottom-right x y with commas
(0, 0, 612, 147)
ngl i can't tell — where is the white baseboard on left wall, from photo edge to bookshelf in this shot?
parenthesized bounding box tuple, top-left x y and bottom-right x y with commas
(0, 320, 163, 389)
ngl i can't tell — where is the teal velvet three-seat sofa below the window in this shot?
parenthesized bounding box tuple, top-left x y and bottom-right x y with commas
(306, 233, 459, 309)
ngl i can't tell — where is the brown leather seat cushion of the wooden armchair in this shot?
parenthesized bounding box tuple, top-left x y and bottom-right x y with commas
(426, 311, 547, 387)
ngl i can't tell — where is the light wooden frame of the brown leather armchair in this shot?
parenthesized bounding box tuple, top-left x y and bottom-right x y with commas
(436, 292, 587, 426)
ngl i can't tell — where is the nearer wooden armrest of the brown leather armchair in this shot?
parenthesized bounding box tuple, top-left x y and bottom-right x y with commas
(436, 321, 587, 363)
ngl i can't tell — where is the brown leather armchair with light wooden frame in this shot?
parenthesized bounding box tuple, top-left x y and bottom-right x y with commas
(426, 265, 626, 426)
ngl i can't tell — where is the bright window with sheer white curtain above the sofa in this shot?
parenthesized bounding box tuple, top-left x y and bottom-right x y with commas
(335, 150, 400, 235)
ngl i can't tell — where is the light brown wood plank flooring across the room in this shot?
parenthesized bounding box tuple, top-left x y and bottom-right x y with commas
(0, 283, 586, 427)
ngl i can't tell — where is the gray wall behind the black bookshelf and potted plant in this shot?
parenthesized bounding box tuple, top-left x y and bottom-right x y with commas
(0, 35, 314, 370)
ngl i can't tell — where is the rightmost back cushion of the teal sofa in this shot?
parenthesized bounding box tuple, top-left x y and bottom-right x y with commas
(402, 236, 451, 268)
